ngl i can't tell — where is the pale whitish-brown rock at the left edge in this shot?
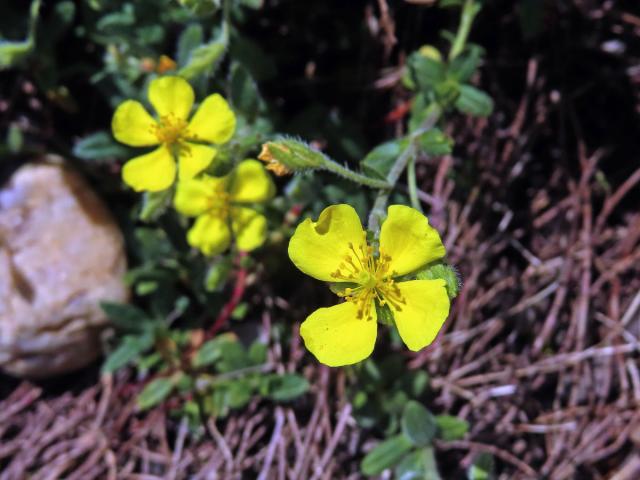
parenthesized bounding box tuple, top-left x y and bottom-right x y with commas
(0, 161, 128, 378)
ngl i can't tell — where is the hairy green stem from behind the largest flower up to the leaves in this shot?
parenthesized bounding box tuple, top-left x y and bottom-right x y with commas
(368, 104, 442, 235)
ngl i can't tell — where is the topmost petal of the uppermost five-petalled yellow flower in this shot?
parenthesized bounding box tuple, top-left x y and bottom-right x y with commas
(149, 77, 194, 121)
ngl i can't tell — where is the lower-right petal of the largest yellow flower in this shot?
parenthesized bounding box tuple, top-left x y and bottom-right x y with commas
(388, 279, 449, 352)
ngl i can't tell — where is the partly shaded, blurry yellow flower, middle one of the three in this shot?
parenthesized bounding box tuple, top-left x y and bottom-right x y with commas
(173, 160, 275, 255)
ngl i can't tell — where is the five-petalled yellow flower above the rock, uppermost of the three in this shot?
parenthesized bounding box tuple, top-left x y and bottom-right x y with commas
(111, 77, 236, 192)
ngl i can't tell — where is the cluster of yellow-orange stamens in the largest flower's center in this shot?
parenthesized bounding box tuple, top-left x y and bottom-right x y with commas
(331, 242, 406, 320)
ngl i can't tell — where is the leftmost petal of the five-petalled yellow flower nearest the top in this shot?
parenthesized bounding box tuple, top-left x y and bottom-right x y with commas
(111, 100, 160, 147)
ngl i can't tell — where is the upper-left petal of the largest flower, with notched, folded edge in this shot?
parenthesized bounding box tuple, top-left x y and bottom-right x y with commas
(289, 204, 366, 282)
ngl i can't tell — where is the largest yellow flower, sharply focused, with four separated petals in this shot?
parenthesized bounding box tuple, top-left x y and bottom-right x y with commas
(289, 205, 449, 367)
